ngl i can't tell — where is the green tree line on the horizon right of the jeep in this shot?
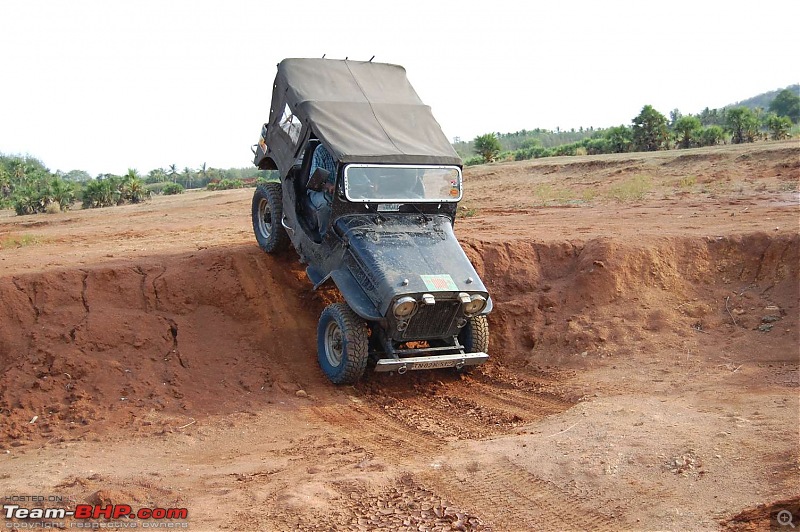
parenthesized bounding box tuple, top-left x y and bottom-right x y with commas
(466, 89, 800, 166)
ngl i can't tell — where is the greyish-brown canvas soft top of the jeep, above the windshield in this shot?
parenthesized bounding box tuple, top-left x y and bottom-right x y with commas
(267, 59, 461, 175)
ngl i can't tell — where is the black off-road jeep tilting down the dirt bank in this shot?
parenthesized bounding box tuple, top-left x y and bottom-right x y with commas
(252, 59, 492, 384)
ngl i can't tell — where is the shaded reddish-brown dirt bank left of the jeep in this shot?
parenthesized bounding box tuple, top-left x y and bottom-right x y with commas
(0, 247, 324, 443)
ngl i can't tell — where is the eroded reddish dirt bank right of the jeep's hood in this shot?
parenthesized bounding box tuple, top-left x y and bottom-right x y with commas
(466, 233, 800, 366)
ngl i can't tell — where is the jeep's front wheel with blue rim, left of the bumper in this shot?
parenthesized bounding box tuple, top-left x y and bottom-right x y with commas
(317, 303, 369, 384)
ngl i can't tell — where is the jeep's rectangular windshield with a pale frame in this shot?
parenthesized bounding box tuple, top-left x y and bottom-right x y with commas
(344, 164, 461, 203)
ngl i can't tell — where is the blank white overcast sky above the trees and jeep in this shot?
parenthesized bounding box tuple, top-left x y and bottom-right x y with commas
(0, 0, 800, 175)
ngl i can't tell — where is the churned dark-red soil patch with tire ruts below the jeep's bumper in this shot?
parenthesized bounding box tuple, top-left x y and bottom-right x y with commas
(296, 362, 578, 452)
